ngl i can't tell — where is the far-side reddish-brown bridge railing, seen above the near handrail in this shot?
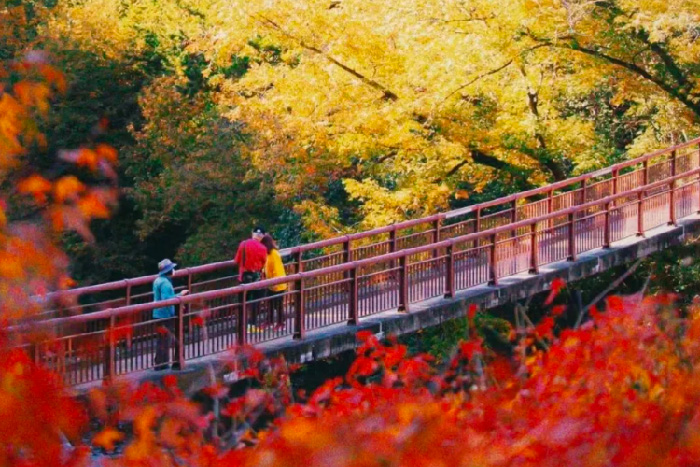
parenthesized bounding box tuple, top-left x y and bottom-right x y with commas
(41, 139, 700, 318)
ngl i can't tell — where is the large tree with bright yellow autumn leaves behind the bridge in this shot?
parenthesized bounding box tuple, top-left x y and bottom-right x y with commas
(46, 0, 699, 241)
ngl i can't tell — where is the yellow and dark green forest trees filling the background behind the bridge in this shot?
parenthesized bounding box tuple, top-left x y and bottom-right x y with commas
(0, 0, 700, 283)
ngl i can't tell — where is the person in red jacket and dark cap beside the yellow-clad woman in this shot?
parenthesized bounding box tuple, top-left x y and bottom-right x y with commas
(233, 227, 267, 330)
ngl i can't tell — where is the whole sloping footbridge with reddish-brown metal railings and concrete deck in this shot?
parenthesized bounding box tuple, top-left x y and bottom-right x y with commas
(16, 138, 700, 387)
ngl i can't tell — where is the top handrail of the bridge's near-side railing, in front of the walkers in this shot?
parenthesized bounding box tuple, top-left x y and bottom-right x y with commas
(26, 162, 700, 331)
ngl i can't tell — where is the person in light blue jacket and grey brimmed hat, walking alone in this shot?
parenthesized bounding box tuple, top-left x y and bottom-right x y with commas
(153, 259, 188, 371)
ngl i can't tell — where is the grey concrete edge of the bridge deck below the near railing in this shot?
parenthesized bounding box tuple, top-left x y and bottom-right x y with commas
(68, 215, 700, 393)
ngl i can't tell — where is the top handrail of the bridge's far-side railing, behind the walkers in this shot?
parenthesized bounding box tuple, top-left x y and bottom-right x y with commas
(42, 138, 700, 308)
